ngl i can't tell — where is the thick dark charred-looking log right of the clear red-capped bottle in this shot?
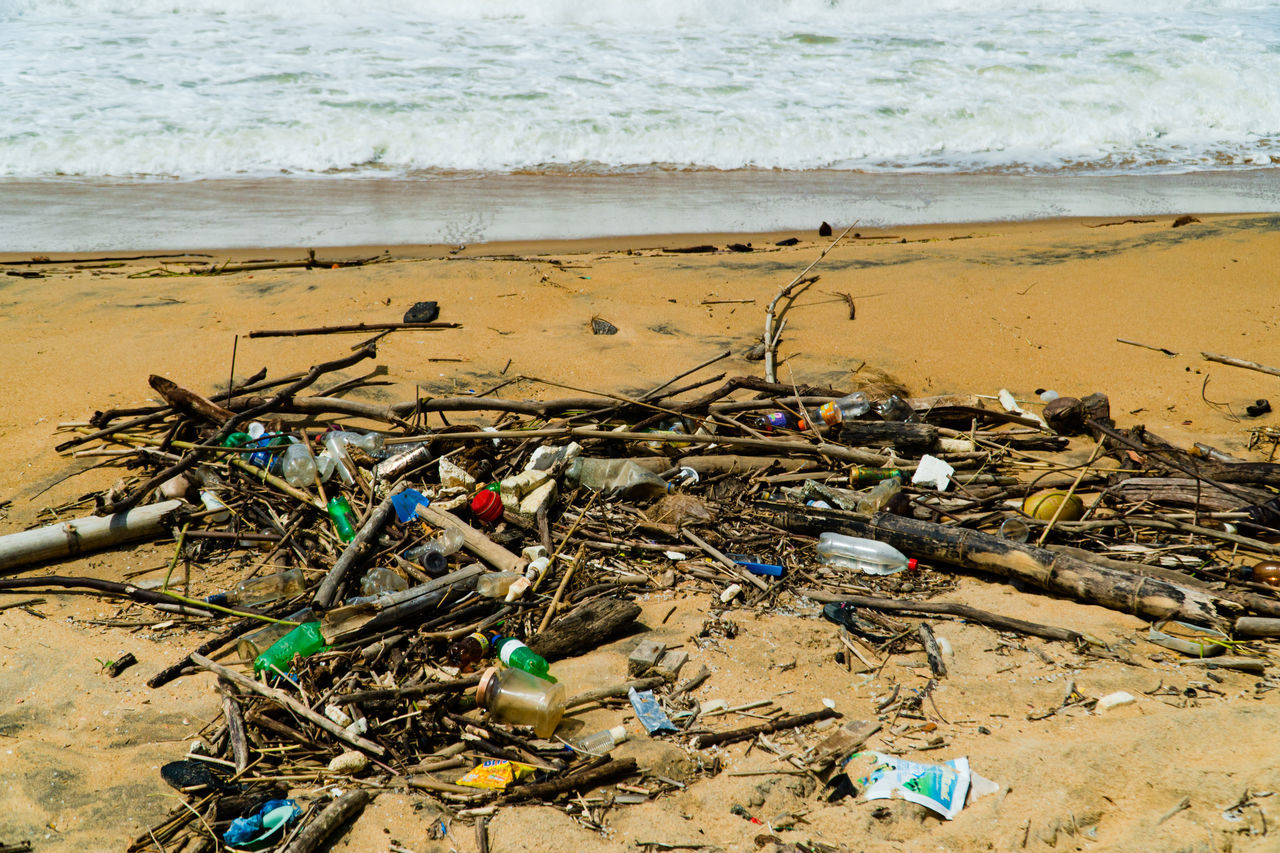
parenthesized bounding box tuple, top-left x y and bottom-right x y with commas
(760, 502, 1239, 628)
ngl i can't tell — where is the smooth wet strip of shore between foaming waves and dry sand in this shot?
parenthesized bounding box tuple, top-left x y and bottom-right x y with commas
(0, 169, 1280, 252)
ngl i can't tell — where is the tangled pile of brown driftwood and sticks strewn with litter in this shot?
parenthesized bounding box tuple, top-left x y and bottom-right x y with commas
(0, 346, 1280, 852)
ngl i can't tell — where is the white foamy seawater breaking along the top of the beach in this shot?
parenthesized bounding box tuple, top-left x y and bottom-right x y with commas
(0, 0, 1280, 248)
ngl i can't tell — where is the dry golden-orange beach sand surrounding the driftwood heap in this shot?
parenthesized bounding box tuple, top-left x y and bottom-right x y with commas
(0, 215, 1280, 852)
